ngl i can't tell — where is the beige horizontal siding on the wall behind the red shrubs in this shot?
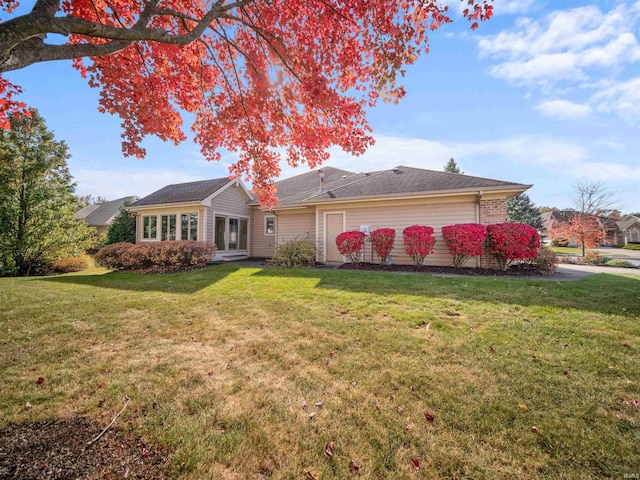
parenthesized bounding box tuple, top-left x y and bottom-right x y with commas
(318, 197, 477, 266)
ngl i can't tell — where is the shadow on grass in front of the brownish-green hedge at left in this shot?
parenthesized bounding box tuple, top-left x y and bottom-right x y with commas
(38, 264, 240, 294)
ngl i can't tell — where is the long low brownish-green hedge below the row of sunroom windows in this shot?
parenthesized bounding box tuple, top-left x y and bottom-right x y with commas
(96, 240, 216, 270)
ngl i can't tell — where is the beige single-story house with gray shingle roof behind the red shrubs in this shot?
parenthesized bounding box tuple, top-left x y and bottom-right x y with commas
(128, 166, 531, 266)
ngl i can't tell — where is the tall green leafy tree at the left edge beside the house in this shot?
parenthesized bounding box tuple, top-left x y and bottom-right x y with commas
(0, 111, 94, 275)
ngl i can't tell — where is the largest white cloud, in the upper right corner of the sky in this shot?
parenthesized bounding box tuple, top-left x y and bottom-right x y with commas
(478, 4, 640, 87)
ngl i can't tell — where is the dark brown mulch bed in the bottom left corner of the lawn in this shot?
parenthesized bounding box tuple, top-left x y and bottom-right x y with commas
(0, 418, 170, 480)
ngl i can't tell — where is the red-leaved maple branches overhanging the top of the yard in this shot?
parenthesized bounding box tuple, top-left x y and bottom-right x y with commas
(0, 0, 492, 204)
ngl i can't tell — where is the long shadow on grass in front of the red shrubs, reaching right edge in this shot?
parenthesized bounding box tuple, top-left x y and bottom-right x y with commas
(253, 268, 640, 316)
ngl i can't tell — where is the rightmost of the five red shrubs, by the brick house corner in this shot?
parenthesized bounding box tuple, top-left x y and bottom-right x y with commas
(487, 222, 540, 270)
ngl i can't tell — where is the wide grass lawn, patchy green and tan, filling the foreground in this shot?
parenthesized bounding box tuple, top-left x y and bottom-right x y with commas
(0, 265, 640, 479)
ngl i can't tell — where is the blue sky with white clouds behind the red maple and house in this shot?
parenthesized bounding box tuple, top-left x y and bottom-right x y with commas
(7, 0, 640, 212)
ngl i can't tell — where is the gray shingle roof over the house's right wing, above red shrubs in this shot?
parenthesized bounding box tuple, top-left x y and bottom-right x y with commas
(268, 166, 530, 206)
